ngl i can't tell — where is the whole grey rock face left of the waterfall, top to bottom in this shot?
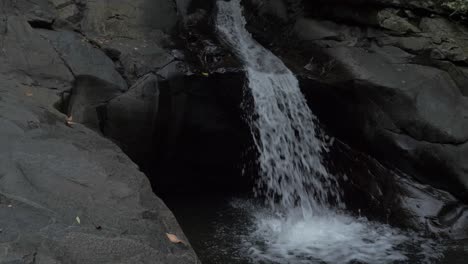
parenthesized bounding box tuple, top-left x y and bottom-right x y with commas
(0, 0, 199, 264)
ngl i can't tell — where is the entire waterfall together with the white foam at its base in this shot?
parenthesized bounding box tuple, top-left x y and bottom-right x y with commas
(216, 0, 440, 263)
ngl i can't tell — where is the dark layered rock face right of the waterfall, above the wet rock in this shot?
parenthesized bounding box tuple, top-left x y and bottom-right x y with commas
(243, 0, 468, 199)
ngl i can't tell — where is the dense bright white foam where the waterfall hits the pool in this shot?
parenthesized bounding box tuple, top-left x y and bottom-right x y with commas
(249, 212, 409, 264)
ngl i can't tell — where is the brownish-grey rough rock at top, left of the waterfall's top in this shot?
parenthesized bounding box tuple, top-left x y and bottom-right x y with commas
(80, 0, 177, 84)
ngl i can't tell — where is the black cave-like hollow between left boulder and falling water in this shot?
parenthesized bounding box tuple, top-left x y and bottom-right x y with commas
(135, 73, 256, 200)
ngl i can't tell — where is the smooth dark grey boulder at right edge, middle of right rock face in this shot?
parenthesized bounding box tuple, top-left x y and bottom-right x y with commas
(326, 48, 468, 144)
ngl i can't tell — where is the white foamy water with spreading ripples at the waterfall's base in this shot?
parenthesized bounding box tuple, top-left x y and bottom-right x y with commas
(229, 199, 443, 264)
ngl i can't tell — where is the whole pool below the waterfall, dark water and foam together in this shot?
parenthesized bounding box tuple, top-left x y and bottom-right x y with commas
(165, 196, 468, 264)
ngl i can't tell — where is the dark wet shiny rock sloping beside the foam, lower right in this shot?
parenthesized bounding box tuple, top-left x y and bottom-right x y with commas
(326, 140, 468, 239)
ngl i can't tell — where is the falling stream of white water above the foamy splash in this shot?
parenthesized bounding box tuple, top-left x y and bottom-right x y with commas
(217, 0, 339, 217)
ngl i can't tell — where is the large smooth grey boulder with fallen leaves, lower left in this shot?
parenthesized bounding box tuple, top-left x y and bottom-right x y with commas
(0, 76, 198, 264)
